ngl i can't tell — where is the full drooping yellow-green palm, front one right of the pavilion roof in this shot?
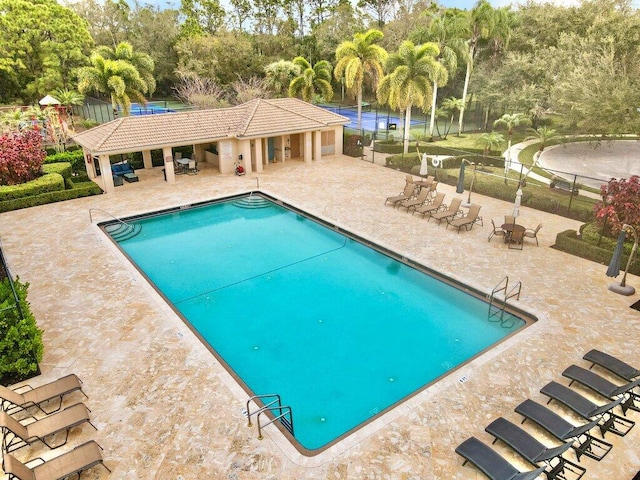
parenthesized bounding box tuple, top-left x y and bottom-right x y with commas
(377, 40, 449, 154)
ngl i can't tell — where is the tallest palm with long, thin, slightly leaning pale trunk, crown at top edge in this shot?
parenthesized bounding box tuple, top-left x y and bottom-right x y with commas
(458, 0, 509, 136)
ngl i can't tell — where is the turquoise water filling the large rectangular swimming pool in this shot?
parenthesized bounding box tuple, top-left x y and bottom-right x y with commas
(107, 195, 525, 454)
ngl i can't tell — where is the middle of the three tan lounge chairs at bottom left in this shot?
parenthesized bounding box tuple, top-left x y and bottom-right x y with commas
(0, 403, 97, 453)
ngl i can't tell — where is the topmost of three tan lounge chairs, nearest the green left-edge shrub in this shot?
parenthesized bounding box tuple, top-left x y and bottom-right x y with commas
(0, 374, 89, 414)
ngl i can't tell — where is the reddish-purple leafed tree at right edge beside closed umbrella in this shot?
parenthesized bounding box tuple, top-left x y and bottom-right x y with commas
(594, 175, 640, 235)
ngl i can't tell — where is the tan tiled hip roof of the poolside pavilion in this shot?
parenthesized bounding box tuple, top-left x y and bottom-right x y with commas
(73, 98, 349, 155)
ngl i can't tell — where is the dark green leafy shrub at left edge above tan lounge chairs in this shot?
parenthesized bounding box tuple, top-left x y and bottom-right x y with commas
(0, 278, 44, 385)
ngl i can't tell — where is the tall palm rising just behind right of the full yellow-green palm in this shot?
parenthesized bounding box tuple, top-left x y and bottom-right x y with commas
(415, 10, 469, 138)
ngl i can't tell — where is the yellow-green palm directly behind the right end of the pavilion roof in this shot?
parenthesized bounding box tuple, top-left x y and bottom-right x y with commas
(334, 29, 387, 130)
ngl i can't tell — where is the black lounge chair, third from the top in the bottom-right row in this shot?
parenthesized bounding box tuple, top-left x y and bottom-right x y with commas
(540, 382, 635, 437)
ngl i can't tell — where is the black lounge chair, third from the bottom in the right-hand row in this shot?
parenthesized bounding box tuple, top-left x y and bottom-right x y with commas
(515, 400, 612, 461)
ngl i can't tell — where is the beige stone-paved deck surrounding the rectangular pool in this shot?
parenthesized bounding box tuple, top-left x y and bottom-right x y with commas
(0, 156, 640, 480)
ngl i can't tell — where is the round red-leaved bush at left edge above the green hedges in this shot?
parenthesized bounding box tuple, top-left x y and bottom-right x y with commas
(0, 130, 46, 185)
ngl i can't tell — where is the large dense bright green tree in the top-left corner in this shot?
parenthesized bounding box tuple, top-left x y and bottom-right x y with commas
(0, 0, 93, 103)
